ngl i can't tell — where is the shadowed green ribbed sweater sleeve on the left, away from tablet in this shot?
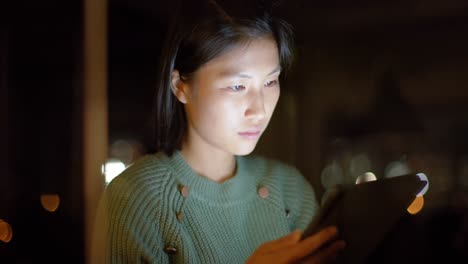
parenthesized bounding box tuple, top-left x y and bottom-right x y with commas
(92, 170, 169, 263)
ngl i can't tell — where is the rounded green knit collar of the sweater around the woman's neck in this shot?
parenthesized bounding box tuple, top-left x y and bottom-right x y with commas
(163, 151, 258, 205)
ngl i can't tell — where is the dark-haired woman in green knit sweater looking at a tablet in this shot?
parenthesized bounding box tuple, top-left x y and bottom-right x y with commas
(93, 1, 344, 263)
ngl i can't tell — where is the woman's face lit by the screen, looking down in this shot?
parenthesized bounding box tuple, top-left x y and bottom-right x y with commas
(179, 39, 281, 155)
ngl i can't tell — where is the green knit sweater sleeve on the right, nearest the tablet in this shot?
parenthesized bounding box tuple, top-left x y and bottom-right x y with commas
(285, 167, 319, 231)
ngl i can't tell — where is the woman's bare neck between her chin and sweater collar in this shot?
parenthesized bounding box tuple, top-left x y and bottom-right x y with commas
(180, 137, 236, 183)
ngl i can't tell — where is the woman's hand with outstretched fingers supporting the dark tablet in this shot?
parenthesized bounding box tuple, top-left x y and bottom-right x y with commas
(247, 227, 345, 264)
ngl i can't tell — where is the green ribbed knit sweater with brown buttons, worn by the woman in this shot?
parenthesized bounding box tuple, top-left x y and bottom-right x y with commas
(92, 152, 317, 263)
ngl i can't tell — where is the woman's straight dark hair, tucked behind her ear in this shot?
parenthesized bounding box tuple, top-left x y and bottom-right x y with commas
(153, 0, 293, 155)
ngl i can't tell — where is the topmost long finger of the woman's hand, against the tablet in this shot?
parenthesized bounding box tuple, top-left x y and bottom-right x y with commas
(287, 227, 338, 261)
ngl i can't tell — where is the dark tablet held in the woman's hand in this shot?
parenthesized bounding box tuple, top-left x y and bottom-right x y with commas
(303, 173, 428, 264)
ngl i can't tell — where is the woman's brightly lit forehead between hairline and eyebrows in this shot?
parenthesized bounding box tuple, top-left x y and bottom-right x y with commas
(199, 38, 280, 76)
